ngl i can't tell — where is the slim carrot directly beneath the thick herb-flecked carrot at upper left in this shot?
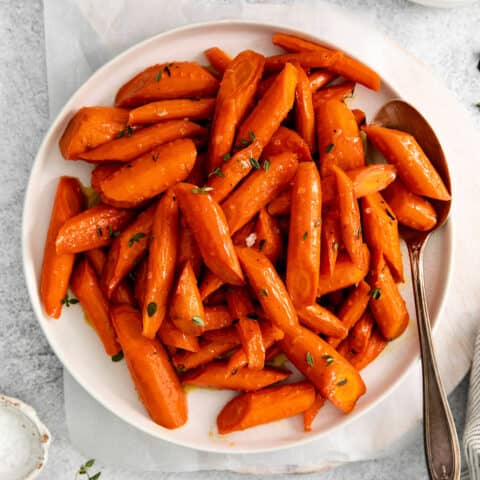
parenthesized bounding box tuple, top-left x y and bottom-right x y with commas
(128, 98, 215, 125)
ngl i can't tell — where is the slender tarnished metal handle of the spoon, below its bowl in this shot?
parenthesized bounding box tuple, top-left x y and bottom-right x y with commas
(408, 241, 460, 480)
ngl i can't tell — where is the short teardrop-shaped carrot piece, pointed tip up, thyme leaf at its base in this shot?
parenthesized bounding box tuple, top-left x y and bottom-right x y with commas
(170, 262, 205, 335)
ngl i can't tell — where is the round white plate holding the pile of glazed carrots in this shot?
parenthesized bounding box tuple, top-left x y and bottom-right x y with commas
(22, 22, 453, 453)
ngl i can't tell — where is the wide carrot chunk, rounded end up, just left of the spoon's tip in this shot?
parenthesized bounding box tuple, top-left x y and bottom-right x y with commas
(316, 99, 365, 177)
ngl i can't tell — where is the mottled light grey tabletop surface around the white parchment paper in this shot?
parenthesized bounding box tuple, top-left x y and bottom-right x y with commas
(0, 0, 480, 480)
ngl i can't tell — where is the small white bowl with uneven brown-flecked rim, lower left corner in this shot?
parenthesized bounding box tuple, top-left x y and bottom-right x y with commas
(0, 395, 52, 480)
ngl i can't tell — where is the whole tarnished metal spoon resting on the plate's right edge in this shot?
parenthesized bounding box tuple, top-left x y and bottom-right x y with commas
(373, 100, 460, 480)
